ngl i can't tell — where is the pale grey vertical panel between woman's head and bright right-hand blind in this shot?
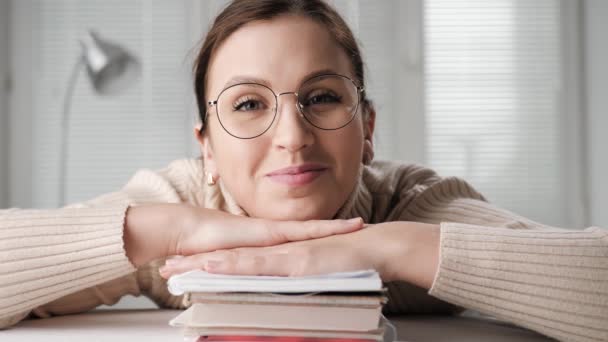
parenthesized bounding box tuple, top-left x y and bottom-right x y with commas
(330, 0, 424, 162)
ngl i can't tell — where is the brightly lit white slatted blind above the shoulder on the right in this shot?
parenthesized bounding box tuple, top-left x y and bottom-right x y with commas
(424, 0, 573, 225)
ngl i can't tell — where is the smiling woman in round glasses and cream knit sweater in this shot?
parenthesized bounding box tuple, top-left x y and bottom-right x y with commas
(0, 0, 608, 341)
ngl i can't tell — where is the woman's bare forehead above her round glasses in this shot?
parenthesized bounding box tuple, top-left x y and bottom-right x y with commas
(206, 16, 353, 96)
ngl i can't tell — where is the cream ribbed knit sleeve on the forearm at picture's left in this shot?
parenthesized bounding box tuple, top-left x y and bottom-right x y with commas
(0, 193, 135, 328)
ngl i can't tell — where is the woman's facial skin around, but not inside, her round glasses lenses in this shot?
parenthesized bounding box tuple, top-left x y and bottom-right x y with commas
(199, 16, 373, 220)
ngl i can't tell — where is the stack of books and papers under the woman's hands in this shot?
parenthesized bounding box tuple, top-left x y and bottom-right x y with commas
(168, 270, 387, 342)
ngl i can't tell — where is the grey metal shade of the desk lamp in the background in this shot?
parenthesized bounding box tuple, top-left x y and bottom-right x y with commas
(80, 31, 139, 94)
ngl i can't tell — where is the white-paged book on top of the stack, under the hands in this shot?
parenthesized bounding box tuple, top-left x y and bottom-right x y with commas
(168, 270, 382, 296)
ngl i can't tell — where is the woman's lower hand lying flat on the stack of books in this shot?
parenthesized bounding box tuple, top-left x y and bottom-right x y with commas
(160, 221, 439, 289)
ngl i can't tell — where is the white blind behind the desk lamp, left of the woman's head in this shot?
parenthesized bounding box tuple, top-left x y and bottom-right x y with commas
(12, 0, 194, 207)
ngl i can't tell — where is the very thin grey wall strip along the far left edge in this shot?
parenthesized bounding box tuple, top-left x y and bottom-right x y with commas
(0, 1, 10, 208)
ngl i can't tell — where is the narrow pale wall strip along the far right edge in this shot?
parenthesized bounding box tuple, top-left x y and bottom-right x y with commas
(583, 0, 608, 228)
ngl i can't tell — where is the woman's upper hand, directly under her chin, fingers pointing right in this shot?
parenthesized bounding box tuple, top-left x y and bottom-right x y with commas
(124, 204, 363, 267)
